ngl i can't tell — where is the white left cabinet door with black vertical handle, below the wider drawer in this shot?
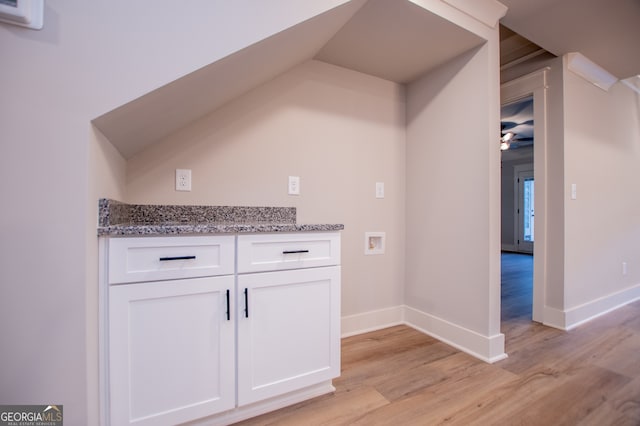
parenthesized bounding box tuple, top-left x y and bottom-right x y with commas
(109, 275, 235, 425)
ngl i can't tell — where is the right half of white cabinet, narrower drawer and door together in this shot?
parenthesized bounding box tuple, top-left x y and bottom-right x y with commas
(237, 233, 340, 405)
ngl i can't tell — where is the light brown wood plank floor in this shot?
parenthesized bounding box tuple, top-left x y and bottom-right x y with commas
(234, 256, 640, 426)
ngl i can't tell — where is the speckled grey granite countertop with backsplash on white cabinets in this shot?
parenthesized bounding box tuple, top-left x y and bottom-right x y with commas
(98, 199, 344, 236)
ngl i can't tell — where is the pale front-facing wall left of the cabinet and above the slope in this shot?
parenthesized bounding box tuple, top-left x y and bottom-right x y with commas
(0, 0, 344, 425)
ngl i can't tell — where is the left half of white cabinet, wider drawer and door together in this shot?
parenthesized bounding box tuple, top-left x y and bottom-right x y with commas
(105, 236, 236, 425)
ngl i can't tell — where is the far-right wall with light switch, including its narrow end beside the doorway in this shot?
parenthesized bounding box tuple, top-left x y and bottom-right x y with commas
(508, 58, 640, 329)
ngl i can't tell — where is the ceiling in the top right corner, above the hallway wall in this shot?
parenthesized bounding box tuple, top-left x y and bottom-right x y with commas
(500, 0, 640, 79)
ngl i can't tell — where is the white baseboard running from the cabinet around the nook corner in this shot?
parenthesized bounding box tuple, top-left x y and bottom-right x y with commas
(342, 305, 507, 363)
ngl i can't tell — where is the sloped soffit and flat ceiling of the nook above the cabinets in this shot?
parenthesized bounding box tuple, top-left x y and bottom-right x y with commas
(93, 0, 484, 159)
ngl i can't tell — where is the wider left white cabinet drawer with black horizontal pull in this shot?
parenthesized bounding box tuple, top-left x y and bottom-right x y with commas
(109, 235, 235, 284)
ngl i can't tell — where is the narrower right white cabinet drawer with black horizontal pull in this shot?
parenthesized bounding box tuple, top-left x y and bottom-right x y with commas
(238, 232, 340, 273)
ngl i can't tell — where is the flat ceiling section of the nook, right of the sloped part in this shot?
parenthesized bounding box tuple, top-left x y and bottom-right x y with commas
(315, 0, 484, 83)
